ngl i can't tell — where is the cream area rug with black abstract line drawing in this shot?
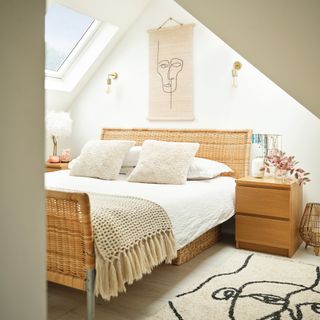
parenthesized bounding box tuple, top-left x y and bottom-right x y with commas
(150, 253, 320, 320)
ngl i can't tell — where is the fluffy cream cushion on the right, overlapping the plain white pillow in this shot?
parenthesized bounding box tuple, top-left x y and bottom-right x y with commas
(128, 140, 199, 184)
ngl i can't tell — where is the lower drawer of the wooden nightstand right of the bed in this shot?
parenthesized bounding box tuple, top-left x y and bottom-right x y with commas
(236, 214, 290, 248)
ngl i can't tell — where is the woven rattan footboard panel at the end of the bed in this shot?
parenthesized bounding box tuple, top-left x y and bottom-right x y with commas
(46, 191, 95, 290)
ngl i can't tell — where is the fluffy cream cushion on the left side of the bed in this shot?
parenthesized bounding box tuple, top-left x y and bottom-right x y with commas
(70, 140, 135, 180)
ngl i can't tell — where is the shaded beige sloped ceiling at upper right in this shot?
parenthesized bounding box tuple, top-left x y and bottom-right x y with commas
(175, 0, 320, 119)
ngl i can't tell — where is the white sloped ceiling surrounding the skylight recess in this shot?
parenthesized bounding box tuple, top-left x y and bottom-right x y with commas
(46, 0, 150, 110)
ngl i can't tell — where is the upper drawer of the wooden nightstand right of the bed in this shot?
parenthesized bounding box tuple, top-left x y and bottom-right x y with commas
(236, 186, 290, 219)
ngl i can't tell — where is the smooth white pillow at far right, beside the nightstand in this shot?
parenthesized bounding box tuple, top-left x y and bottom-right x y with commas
(187, 158, 233, 180)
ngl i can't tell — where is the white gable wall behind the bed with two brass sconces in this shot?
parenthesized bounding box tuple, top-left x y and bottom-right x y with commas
(67, 0, 320, 201)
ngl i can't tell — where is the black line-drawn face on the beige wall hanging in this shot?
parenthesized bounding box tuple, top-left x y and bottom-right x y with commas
(157, 40, 184, 109)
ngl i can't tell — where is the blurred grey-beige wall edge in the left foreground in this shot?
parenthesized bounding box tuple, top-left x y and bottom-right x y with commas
(0, 0, 46, 320)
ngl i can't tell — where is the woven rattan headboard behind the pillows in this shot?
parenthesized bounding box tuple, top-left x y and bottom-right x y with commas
(101, 128, 252, 178)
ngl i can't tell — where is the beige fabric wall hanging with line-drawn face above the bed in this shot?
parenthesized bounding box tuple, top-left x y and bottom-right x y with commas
(148, 18, 194, 120)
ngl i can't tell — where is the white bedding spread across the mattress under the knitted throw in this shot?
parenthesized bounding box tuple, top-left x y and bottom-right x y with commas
(45, 170, 235, 249)
